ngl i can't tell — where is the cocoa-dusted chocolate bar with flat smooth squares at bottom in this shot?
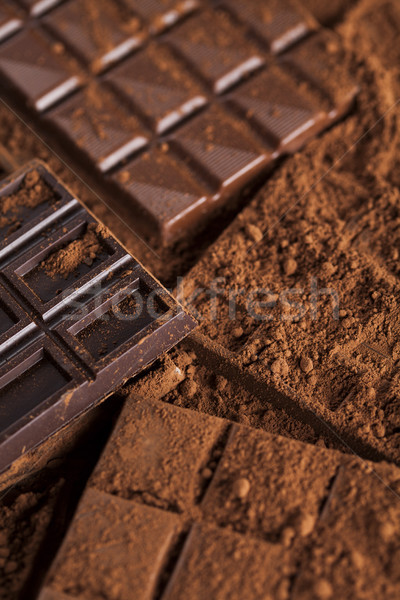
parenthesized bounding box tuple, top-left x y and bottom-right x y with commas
(39, 394, 399, 600)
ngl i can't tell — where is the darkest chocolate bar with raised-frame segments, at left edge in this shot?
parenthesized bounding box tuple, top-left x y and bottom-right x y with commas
(0, 161, 195, 470)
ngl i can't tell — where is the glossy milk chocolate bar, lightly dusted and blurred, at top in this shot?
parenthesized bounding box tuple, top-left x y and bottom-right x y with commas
(0, 0, 357, 245)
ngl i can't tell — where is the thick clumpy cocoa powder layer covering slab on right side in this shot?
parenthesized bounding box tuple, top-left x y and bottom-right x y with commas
(186, 2, 400, 461)
